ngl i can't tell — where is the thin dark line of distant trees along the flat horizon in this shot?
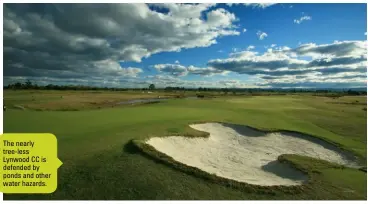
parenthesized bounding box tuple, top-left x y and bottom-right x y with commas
(4, 80, 367, 96)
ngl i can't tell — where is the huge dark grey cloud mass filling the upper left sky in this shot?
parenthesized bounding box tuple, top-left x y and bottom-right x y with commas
(3, 4, 240, 85)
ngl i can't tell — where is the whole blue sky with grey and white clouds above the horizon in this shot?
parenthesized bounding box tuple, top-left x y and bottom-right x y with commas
(3, 3, 368, 88)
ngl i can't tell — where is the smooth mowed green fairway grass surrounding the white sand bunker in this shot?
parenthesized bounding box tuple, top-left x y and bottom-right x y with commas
(4, 91, 367, 200)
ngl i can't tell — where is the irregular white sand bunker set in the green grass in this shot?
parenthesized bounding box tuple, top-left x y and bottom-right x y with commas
(146, 123, 354, 186)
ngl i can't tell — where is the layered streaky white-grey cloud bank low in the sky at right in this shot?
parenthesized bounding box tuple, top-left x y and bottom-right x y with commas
(208, 41, 367, 86)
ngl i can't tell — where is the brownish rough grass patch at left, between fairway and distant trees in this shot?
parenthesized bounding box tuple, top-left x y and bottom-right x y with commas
(4, 90, 181, 111)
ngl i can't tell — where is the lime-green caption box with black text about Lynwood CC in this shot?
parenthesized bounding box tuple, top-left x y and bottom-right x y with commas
(0, 133, 62, 193)
